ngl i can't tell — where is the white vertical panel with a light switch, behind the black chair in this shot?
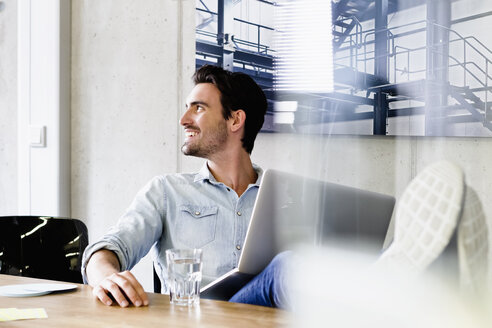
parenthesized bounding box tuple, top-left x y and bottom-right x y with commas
(17, 0, 71, 217)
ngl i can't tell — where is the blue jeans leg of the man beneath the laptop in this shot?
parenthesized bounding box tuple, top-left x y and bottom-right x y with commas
(229, 252, 290, 310)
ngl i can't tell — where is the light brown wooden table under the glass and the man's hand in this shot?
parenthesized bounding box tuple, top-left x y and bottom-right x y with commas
(0, 275, 289, 328)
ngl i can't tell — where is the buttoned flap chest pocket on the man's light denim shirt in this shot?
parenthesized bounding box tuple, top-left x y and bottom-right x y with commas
(176, 205, 219, 248)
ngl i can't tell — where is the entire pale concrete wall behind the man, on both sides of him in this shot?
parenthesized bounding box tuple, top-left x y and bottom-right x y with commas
(0, 0, 492, 290)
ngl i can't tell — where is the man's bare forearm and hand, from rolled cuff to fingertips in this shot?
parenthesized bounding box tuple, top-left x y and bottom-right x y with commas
(86, 249, 149, 307)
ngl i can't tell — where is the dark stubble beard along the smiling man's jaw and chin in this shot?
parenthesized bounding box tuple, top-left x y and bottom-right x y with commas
(181, 121, 227, 158)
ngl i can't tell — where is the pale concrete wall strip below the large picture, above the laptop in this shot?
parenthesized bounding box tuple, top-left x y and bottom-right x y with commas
(183, 133, 492, 238)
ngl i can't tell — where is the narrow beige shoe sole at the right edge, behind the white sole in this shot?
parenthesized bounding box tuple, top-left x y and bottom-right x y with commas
(458, 186, 489, 294)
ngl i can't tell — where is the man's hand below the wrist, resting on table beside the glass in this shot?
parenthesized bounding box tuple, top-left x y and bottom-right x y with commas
(92, 271, 149, 307)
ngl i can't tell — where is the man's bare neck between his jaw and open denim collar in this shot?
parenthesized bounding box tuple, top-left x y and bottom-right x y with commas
(207, 149, 258, 196)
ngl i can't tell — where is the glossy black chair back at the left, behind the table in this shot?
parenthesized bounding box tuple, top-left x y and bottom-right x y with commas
(0, 216, 88, 283)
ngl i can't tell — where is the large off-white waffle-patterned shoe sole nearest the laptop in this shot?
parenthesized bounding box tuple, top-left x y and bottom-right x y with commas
(376, 161, 465, 273)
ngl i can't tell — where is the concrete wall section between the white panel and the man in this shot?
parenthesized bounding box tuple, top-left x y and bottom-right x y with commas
(72, 0, 195, 290)
